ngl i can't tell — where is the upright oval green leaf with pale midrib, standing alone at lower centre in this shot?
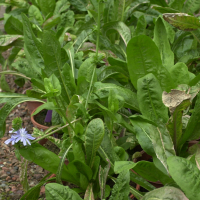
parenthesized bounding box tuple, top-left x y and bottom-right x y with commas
(85, 119, 104, 167)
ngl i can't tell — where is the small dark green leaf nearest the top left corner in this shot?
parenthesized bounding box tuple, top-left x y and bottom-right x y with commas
(4, 15, 23, 35)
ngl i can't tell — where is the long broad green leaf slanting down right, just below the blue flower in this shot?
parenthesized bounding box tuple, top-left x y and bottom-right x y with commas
(19, 143, 79, 185)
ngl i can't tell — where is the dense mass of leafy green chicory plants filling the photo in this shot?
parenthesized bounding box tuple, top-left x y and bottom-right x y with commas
(0, 0, 200, 200)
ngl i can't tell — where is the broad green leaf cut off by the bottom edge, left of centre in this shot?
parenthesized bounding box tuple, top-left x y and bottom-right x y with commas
(45, 183, 82, 200)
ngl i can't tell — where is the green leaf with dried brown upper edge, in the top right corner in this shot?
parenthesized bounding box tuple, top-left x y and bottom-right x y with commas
(163, 13, 200, 31)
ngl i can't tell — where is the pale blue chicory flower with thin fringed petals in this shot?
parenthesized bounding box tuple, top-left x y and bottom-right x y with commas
(5, 128, 35, 146)
